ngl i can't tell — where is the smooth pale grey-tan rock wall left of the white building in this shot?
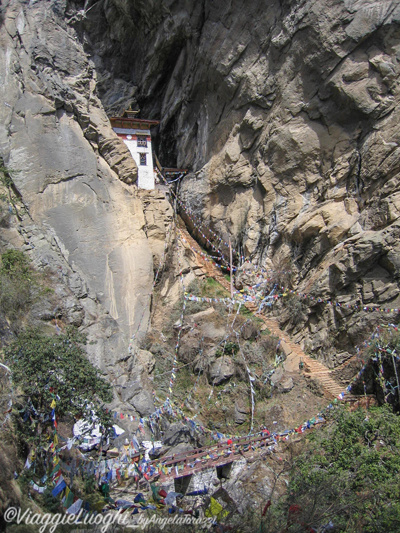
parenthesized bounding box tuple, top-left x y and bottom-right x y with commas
(0, 0, 170, 414)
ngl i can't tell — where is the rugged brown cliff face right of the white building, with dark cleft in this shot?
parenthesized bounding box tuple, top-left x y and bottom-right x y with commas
(81, 0, 400, 353)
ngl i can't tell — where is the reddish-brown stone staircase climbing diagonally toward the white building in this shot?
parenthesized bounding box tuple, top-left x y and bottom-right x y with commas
(179, 220, 348, 398)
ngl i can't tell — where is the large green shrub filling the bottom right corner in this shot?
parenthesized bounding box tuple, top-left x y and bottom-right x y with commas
(287, 407, 400, 533)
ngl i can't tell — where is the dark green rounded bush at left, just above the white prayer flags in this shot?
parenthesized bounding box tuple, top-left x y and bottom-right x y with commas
(5, 328, 112, 446)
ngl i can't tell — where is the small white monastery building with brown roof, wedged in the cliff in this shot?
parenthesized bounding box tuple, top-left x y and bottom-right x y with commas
(110, 111, 159, 190)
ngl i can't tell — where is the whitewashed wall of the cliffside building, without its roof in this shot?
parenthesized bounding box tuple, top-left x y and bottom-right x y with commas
(114, 128, 154, 190)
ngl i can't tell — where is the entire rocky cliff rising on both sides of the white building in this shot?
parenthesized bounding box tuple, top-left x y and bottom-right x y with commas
(0, 0, 400, 365)
